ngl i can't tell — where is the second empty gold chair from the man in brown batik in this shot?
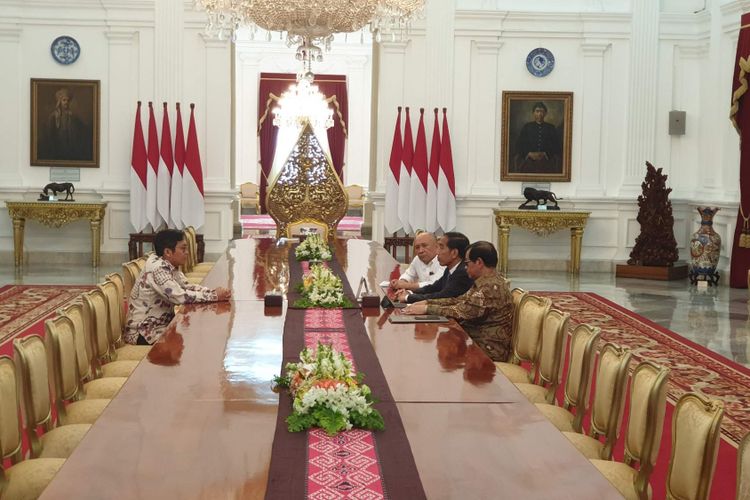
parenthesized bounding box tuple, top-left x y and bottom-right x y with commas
(512, 309, 570, 403)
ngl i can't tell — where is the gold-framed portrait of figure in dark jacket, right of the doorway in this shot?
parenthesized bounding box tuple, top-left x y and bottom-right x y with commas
(500, 91, 573, 182)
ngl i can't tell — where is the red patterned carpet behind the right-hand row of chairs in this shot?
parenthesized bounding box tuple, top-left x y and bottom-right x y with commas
(534, 292, 750, 500)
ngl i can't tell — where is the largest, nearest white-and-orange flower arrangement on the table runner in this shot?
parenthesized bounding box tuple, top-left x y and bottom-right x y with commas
(274, 343, 385, 436)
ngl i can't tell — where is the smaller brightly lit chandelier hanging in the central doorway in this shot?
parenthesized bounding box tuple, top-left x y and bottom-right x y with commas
(273, 71, 333, 131)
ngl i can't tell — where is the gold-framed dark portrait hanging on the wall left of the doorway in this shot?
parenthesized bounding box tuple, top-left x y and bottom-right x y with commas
(30, 78, 99, 167)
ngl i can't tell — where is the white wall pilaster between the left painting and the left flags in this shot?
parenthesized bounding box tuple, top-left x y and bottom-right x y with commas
(100, 29, 137, 189)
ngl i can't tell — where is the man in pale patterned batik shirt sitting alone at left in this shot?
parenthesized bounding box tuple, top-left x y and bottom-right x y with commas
(123, 229, 231, 345)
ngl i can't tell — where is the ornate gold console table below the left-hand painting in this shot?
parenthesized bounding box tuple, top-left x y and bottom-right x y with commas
(5, 201, 107, 267)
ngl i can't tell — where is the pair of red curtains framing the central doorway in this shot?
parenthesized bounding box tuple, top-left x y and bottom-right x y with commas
(258, 73, 349, 213)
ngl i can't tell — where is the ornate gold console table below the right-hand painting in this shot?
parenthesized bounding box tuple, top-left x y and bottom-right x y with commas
(494, 208, 591, 274)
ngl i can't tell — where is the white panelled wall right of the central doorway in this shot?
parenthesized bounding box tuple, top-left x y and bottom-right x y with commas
(371, 0, 750, 269)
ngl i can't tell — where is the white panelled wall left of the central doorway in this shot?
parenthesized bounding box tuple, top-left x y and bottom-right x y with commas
(0, 0, 234, 262)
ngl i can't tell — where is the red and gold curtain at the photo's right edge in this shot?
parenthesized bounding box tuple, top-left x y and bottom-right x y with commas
(729, 14, 750, 288)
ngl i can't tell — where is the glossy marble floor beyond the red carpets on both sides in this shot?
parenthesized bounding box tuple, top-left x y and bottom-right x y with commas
(0, 264, 750, 367)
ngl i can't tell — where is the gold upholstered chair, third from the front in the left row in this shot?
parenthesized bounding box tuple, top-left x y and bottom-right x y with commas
(44, 316, 114, 425)
